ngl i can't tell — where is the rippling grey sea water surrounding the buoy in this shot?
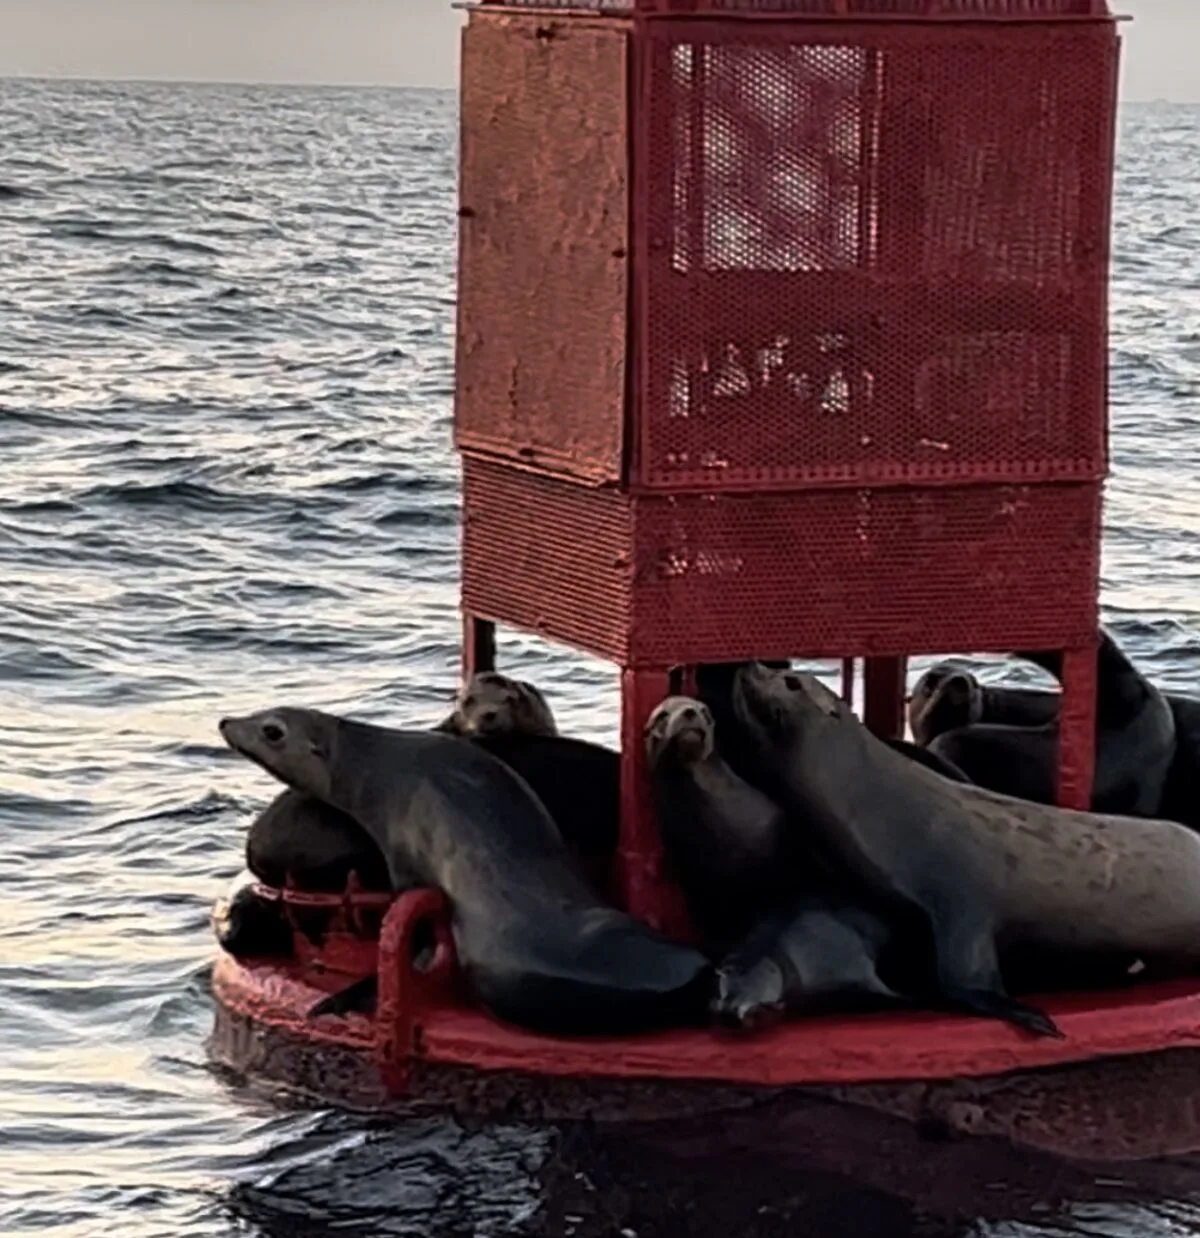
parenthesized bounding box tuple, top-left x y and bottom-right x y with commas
(0, 82, 1200, 1238)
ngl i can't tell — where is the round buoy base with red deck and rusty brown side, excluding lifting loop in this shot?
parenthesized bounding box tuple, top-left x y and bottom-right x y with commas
(211, 930, 1200, 1161)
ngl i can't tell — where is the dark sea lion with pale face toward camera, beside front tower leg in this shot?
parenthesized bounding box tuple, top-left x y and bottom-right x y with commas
(645, 697, 804, 950)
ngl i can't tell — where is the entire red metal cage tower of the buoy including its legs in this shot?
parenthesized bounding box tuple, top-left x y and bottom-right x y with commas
(454, 0, 1120, 925)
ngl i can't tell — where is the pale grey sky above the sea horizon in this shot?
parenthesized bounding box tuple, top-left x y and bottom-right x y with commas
(0, 0, 1200, 100)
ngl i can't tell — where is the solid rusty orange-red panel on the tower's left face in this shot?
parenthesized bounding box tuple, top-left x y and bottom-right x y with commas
(454, 12, 629, 483)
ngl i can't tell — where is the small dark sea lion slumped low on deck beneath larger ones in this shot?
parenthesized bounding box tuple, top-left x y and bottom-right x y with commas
(711, 896, 907, 1031)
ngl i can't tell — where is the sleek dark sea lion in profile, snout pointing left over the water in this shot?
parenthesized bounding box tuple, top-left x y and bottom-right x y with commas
(219, 707, 712, 1035)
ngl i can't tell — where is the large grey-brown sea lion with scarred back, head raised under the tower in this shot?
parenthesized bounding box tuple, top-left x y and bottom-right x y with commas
(734, 667, 1200, 1035)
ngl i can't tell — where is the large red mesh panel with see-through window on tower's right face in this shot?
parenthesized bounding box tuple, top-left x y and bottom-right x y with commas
(635, 16, 1117, 488)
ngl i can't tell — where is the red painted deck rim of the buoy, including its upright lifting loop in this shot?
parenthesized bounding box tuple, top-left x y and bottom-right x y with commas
(213, 890, 1200, 1093)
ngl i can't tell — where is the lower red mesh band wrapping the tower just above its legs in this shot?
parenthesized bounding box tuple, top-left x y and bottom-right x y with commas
(462, 458, 1101, 667)
